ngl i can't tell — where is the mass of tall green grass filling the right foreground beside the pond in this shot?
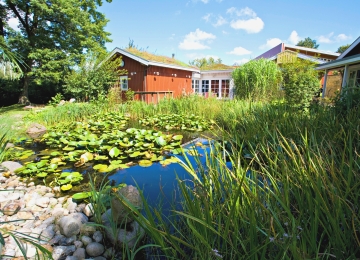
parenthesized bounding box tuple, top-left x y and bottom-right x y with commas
(119, 101, 360, 259)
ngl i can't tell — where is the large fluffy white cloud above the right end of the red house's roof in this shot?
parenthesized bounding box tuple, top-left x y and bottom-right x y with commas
(179, 28, 216, 50)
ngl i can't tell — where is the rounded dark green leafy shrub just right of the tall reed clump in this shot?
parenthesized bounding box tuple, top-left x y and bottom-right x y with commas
(282, 59, 320, 109)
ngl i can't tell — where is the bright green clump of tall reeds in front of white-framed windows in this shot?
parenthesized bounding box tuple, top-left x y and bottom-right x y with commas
(232, 59, 281, 100)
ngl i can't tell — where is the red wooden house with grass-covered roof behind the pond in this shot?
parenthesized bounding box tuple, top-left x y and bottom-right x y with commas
(110, 48, 199, 103)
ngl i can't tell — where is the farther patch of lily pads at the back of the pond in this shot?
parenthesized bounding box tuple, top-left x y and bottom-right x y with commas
(139, 114, 215, 132)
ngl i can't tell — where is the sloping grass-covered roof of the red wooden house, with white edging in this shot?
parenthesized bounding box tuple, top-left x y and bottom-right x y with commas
(109, 48, 199, 72)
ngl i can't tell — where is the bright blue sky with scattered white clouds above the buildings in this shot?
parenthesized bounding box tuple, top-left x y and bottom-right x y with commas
(100, 0, 360, 65)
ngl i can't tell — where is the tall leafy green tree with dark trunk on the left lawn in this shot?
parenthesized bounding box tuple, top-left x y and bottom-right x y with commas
(0, 0, 111, 103)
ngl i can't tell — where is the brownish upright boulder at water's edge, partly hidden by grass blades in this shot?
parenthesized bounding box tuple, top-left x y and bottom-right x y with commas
(111, 185, 143, 224)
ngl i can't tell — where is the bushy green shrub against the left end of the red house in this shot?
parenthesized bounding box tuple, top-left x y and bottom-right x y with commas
(64, 53, 126, 101)
